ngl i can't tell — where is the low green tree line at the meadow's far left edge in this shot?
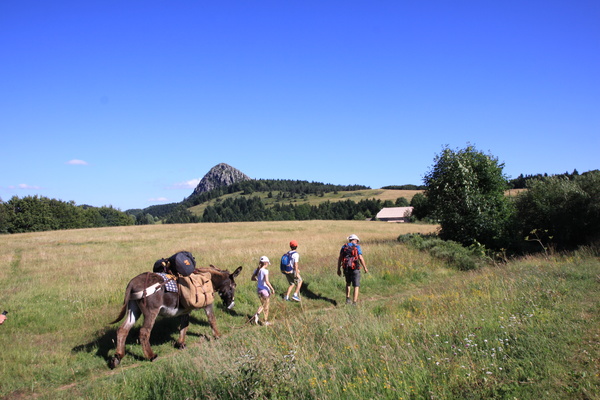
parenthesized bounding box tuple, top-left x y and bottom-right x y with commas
(0, 196, 136, 233)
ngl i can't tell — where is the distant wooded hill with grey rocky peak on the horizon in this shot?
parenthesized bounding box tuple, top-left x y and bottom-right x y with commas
(131, 163, 421, 224)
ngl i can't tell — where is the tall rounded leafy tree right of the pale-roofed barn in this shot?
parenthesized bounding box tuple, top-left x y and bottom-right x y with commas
(424, 146, 511, 248)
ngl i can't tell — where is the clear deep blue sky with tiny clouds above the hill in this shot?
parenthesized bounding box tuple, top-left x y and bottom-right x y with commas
(0, 0, 600, 210)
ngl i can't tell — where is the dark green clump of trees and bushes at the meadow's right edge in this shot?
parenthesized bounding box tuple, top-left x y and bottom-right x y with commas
(412, 146, 600, 253)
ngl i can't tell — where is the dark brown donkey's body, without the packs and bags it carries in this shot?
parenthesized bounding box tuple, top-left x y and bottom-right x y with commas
(109, 265, 242, 368)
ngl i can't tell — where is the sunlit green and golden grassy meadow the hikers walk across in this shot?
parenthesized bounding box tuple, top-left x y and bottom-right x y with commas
(0, 221, 600, 399)
